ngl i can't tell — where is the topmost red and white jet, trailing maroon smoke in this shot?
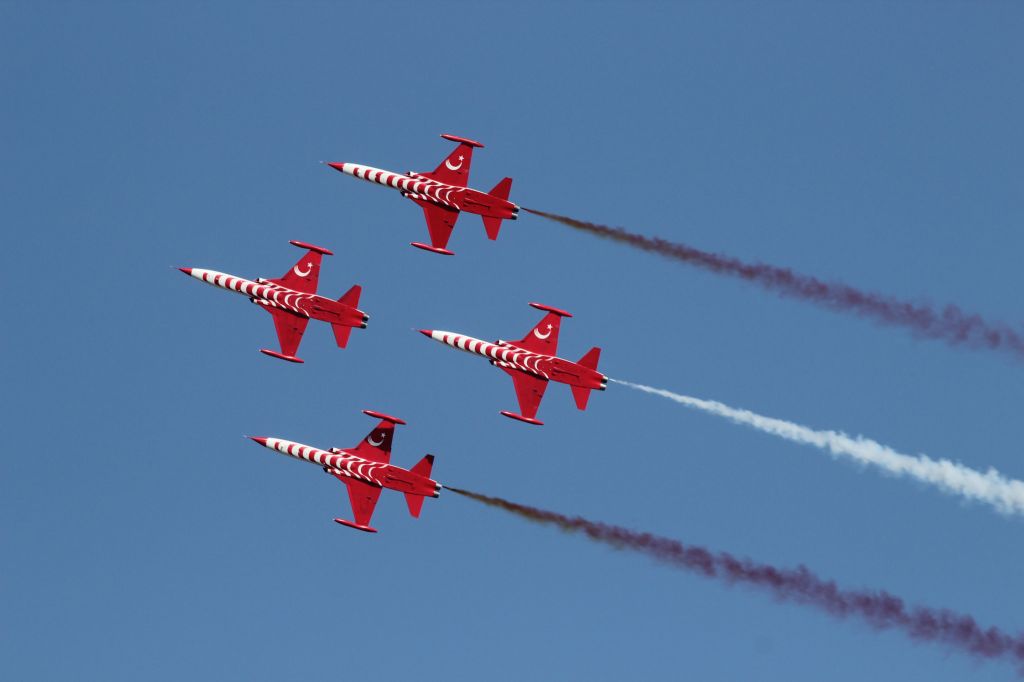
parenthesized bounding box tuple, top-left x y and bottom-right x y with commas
(328, 134, 519, 256)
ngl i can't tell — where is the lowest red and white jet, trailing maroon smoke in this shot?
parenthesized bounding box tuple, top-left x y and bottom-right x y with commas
(248, 410, 441, 532)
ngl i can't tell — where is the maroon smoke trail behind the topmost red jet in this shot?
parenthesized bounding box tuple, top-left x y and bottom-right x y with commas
(523, 207, 1024, 356)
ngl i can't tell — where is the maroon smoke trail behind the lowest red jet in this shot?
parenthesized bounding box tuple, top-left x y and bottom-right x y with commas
(445, 486, 1024, 665)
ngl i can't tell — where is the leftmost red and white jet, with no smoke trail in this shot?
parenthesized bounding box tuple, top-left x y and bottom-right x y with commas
(178, 242, 370, 363)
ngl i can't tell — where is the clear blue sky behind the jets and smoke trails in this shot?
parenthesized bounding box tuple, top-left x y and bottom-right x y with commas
(0, 2, 1024, 681)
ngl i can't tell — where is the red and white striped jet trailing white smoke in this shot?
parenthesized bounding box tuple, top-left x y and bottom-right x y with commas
(420, 303, 608, 426)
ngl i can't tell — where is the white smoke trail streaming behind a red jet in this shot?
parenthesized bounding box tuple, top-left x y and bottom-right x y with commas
(611, 379, 1024, 514)
